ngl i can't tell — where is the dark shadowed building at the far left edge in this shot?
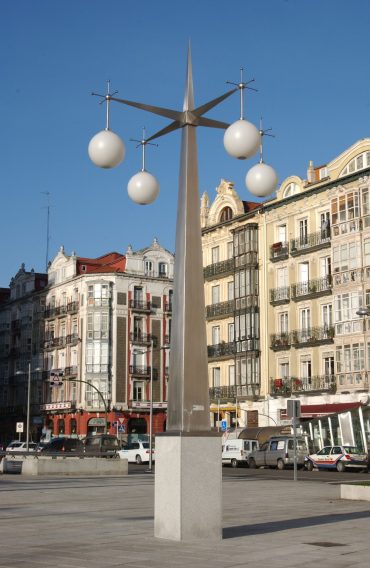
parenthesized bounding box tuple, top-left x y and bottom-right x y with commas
(0, 264, 47, 442)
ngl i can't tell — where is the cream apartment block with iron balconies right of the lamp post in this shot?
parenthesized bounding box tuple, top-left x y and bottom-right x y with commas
(201, 139, 370, 426)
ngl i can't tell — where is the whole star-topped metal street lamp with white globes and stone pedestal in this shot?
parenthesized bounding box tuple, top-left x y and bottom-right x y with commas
(88, 48, 275, 540)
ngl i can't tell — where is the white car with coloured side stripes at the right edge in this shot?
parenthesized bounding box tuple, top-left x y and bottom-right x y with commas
(305, 445, 368, 471)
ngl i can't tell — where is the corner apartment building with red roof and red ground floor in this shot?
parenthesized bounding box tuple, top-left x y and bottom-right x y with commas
(42, 239, 174, 435)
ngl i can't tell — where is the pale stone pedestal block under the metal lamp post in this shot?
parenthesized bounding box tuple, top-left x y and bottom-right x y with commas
(154, 434, 222, 541)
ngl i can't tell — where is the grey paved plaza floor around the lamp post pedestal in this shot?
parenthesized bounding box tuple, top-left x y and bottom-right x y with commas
(0, 474, 370, 568)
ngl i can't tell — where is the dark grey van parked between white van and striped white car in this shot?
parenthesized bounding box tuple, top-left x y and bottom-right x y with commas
(248, 436, 308, 469)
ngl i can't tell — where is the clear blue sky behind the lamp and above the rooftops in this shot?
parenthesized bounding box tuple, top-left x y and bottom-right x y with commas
(0, 0, 370, 287)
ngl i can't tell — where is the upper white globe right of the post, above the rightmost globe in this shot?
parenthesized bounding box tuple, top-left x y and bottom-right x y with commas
(224, 119, 261, 160)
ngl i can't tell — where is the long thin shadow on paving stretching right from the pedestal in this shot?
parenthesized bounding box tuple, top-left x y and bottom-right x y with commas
(223, 511, 370, 538)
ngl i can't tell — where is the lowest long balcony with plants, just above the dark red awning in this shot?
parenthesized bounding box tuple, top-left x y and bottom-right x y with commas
(270, 375, 337, 396)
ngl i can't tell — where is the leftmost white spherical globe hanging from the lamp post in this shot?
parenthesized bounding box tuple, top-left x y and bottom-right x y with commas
(88, 130, 126, 168)
